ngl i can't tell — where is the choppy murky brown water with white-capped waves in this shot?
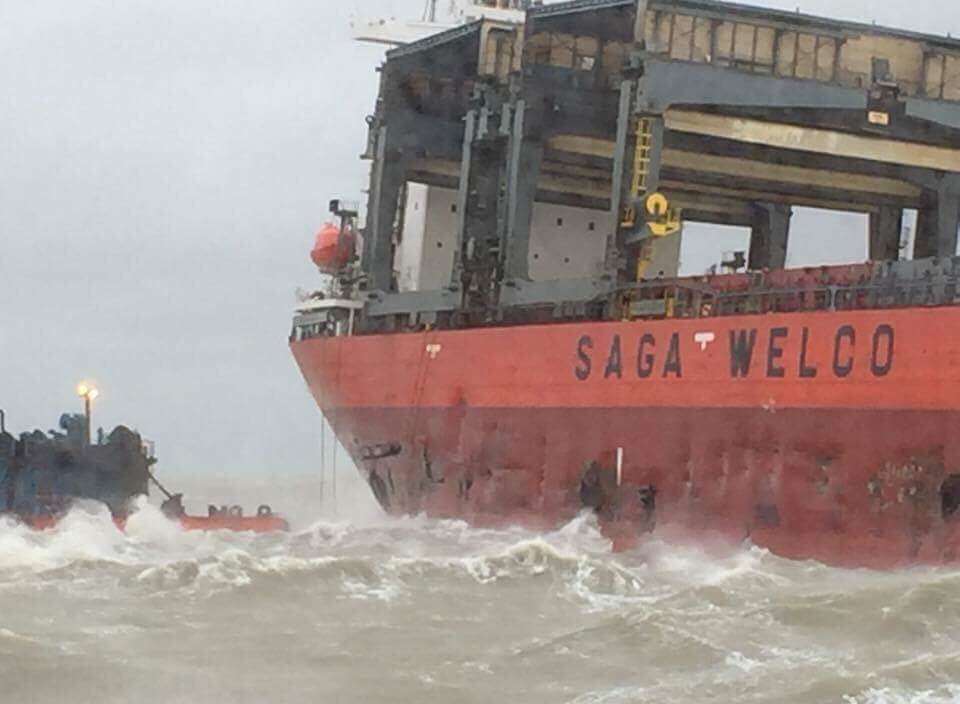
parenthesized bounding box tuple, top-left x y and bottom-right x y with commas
(0, 476, 960, 704)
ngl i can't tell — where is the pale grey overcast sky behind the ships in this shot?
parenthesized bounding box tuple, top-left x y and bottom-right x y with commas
(0, 0, 960, 473)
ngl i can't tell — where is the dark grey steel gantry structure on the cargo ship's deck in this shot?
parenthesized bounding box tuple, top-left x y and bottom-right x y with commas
(354, 0, 960, 315)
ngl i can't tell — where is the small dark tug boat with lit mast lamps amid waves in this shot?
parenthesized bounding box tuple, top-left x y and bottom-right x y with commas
(0, 385, 289, 533)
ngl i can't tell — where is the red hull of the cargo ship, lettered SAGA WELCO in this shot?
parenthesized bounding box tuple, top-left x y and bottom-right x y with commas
(292, 308, 960, 568)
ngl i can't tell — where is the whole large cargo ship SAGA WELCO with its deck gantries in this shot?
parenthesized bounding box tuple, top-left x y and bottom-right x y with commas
(290, 0, 960, 568)
